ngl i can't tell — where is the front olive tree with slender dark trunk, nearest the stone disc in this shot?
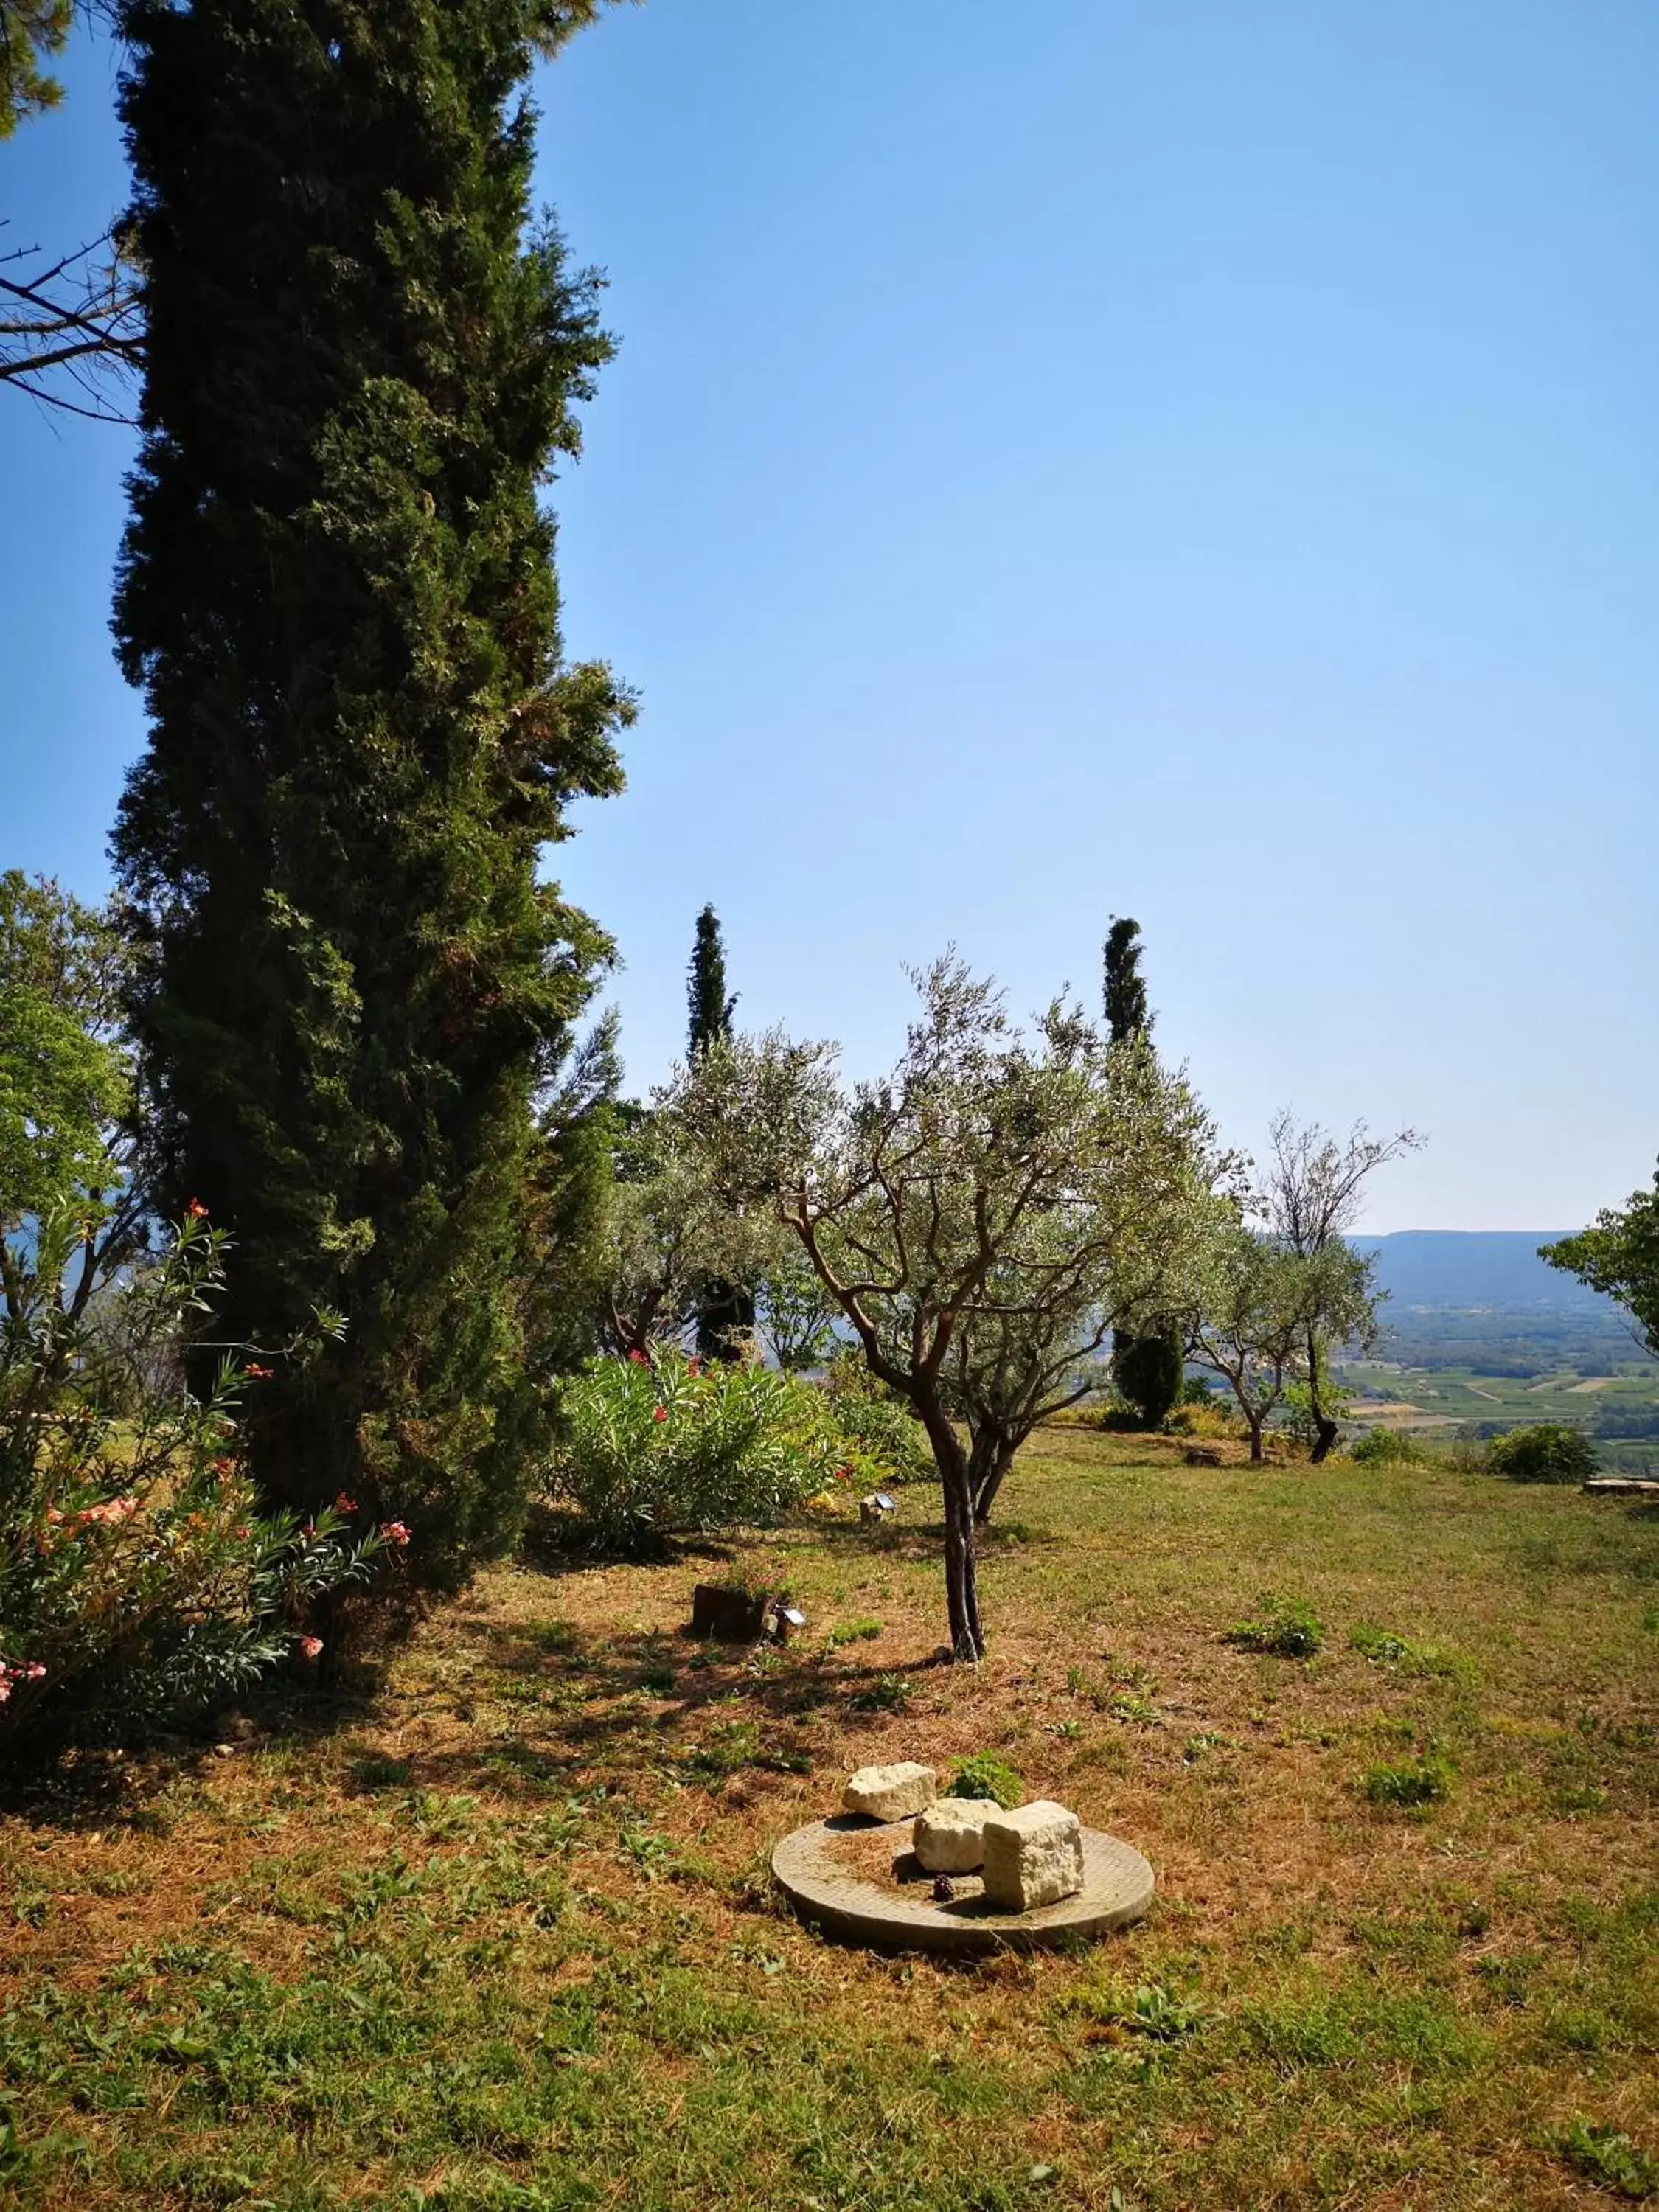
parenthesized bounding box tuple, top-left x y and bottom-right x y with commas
(657, 956, 1217, 1661)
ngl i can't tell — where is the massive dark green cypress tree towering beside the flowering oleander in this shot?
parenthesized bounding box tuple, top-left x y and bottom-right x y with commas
(115, 0, 628, 1584)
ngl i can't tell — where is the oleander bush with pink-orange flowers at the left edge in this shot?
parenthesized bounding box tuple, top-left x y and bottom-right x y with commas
(0, 1208, 387, 1743)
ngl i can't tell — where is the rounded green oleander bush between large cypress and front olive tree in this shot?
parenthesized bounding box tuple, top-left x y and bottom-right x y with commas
(549, 1349, 852, 1551)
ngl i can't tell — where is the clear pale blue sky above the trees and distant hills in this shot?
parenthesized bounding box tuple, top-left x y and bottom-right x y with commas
(0, 0, 1659, 1230)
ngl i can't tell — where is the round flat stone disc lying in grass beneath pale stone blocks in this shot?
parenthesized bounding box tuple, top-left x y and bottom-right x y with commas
(772, 1812, 1152, 1951)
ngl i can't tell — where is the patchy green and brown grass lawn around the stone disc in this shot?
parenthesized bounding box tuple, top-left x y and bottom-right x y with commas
(0, 1429, 1659, 2212)
